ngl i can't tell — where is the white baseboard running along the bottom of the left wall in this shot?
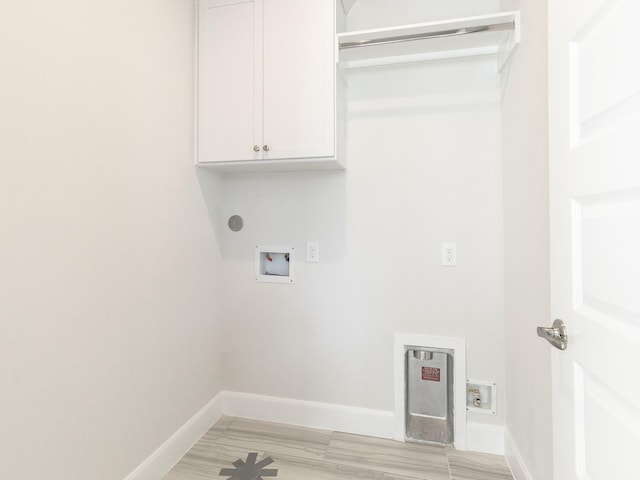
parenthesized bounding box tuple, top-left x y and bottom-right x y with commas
(124, 392, 224, 480)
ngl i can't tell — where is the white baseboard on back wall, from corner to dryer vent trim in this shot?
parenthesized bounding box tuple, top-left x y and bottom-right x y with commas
(224, 392, 394, 438)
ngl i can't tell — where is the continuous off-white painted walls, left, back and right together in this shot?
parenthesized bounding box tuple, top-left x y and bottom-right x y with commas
(0, 0, 551, 480)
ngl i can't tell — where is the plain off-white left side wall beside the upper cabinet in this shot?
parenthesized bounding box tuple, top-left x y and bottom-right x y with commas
(0, 0, 221, 480)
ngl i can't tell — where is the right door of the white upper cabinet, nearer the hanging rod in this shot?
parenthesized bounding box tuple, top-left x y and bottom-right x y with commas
(263, 0, 335, 159)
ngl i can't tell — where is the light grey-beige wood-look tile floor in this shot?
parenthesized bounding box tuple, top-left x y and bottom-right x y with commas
(164, 417, 513, 480)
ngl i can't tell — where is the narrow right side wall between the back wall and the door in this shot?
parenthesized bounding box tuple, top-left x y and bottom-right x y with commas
(502, 0, 553, 480)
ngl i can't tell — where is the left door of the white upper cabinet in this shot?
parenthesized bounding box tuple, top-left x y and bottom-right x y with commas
(198, 0, 262, 162)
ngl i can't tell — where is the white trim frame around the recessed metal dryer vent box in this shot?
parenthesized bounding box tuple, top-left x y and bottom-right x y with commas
(393, 333, 468, 451)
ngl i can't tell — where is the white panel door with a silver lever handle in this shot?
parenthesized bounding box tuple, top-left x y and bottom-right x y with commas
(549, 0, 640, 480)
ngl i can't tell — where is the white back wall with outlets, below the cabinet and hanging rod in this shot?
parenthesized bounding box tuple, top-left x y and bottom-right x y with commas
(223, 2, 505, 430)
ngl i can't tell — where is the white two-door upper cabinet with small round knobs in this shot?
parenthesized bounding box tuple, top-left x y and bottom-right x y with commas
(197, 0, 343, 172)
